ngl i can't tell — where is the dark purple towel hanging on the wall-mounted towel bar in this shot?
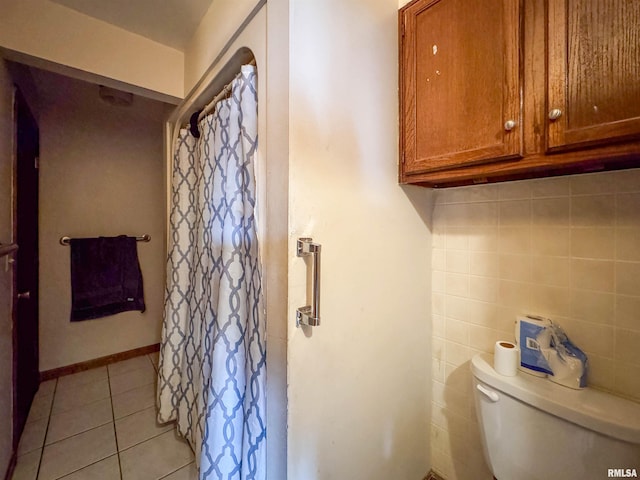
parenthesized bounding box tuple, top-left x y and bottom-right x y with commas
(70, 235, 145, 322)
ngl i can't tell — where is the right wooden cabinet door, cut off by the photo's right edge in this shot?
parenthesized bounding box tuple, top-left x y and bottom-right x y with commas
(547, 0, 640, 151)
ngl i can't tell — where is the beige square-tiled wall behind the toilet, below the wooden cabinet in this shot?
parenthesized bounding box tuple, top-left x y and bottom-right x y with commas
(432, 169, 640, 480)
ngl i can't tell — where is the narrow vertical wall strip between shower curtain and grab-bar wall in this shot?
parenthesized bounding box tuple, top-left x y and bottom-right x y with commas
(258, 0, 292, 479)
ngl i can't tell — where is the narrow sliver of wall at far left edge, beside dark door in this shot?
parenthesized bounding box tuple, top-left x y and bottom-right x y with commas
(0, 58, 14, 476)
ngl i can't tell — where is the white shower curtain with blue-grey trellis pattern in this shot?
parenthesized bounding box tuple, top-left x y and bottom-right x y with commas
(158, 65, 266, 480)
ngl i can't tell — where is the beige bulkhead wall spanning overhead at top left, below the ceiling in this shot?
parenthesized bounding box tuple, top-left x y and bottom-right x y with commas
(0, 0, 184, 99)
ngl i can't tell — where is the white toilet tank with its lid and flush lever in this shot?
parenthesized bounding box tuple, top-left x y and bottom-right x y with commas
(471, 354, 640, 480)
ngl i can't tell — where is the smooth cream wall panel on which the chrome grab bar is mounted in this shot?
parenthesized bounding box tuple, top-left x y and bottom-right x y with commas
(288, 0, 431, 480)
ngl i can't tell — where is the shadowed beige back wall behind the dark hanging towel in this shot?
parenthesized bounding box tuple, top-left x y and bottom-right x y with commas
(40, 74, 165, 371)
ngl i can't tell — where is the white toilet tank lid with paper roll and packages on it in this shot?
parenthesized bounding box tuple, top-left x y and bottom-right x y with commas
(471, 353, 640, 444)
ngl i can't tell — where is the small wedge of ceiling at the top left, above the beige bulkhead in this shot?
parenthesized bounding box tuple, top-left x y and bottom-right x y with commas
(50, 0, 213, 51)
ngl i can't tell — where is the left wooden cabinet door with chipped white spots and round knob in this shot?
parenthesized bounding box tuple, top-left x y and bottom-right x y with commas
(399, 0, 522, 176)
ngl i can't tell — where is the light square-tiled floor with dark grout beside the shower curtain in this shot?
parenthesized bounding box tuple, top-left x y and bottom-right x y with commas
(12, 353, 196, 480)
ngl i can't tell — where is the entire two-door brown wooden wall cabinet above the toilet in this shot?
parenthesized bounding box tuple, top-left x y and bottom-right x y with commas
(399, 0, 640, 186)
